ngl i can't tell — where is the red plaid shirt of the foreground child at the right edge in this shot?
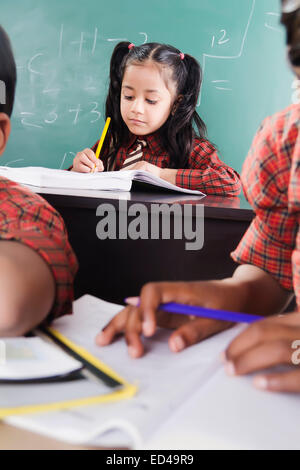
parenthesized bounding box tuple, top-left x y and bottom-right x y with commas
(231, 105, 300, 310)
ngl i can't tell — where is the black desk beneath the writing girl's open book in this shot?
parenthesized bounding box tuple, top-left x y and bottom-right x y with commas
(39, 190, 253, 303)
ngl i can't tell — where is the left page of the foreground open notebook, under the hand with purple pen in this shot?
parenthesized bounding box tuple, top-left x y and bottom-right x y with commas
(6, 295, 245, 448)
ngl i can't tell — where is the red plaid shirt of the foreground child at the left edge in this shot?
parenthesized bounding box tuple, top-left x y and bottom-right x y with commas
(0, 176, 77, 321)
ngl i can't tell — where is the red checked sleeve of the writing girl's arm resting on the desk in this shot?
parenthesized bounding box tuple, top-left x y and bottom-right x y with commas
(176, 139, 241, 196)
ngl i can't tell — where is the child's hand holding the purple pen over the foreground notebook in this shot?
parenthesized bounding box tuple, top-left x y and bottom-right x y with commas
(96, 281, 232, 358)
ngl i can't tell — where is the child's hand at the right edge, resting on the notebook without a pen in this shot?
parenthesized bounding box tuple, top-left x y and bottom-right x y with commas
(225, 312, 300, 392)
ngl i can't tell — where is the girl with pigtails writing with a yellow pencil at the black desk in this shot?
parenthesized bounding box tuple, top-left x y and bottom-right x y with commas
(72, 42, 240, 196)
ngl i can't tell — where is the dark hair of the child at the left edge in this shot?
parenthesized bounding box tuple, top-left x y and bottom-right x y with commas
(0, 26, 17, 116)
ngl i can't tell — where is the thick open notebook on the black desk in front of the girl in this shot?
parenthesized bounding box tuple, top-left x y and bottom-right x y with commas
(0, 166, 205, 196)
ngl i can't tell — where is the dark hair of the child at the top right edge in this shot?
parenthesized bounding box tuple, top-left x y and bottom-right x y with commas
(281, 0, 300, 67)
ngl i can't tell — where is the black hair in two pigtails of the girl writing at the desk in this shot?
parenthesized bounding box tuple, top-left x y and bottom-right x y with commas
(103, 42, 210, 168)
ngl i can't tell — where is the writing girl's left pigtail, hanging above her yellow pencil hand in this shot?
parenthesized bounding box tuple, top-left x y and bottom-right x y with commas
(102, 42, 130, 168)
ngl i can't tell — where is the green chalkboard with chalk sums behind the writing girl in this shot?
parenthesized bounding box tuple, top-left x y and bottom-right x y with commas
(0, 0, 295, 171)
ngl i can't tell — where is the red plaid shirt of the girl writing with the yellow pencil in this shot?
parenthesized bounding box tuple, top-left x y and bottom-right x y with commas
(92, 133, 241, 196)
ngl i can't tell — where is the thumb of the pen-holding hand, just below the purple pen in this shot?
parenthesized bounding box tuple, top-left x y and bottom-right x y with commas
(169, 318, 233, 352)
